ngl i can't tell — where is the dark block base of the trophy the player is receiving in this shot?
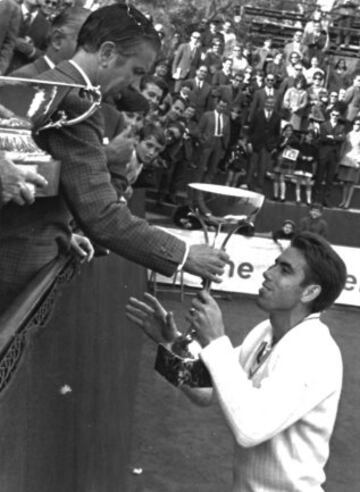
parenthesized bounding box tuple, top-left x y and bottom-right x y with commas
(155, 345, 212, 388)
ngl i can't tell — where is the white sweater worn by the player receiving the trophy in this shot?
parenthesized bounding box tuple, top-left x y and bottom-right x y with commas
(200, 314, 342, 492)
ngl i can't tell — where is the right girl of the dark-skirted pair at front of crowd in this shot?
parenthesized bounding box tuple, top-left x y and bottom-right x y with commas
(294, 130, 318, 205)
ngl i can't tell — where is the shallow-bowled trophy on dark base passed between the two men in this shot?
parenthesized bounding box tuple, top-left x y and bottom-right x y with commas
(155, 183, 265, 387)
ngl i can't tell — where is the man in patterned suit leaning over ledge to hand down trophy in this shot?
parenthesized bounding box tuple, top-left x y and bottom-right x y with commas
(0, 4, 228, 311)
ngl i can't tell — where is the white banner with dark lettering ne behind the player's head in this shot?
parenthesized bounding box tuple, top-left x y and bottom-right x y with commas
(150, 228, 360, 306)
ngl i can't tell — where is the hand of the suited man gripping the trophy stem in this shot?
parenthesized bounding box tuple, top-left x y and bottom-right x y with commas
(184, 244, 230, 283)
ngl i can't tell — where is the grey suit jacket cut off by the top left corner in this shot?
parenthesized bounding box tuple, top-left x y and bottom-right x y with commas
(0, 0, 21, 75)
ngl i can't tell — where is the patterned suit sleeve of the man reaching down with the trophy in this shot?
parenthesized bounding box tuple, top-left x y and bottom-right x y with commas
(38, 98, 185, 276)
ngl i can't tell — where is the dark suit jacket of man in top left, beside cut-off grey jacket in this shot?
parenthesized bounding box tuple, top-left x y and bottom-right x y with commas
(10, 10, 51, 71)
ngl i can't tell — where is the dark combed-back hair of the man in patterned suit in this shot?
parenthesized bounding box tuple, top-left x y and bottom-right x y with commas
(77, 4, 160, 56)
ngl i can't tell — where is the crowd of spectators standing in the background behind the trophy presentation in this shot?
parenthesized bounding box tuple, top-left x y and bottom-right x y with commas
(0, 0, 360, 208)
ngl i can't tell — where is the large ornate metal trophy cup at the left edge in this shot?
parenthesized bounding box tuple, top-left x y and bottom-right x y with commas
(0, 76, 101, 196)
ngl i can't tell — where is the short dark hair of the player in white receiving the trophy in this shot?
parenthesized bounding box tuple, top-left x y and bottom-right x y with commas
(291, 231, 347, 313)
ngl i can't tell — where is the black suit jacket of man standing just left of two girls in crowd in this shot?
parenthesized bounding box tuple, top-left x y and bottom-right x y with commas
(249, 109, 281, 152)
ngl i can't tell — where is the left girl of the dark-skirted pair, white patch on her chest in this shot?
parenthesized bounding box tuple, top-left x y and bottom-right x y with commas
(273, 125, 299, 202)
